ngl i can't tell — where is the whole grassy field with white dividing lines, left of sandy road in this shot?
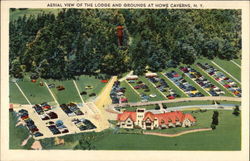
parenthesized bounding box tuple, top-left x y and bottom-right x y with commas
(10, 76, 105, 104)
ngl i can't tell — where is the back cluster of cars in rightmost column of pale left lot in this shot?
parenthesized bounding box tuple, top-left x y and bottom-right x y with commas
(60, 103, 84, 116)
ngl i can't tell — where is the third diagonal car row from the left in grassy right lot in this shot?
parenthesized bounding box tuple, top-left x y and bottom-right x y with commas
(148, 76, 180, 99)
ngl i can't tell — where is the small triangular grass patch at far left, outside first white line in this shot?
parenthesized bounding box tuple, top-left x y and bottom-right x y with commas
(9, 82, 28, 104)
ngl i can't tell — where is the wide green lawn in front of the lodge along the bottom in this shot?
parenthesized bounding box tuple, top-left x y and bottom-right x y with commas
(38, 111, 241, 150)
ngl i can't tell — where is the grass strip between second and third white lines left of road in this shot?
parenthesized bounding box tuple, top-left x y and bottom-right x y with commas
(46, 80, 81, 104)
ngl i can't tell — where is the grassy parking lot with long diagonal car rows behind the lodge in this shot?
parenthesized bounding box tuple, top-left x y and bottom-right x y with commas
(110, 63, 241, 104)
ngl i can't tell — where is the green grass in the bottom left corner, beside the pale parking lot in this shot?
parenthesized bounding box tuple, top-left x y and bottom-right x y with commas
(9, 112, 34, 149)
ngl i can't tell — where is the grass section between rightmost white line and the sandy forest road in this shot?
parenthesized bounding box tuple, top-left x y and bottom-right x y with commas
(74, 75, 106, 101)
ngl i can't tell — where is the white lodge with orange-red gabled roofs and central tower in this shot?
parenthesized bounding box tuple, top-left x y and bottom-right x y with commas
(117, 108, 196, 130)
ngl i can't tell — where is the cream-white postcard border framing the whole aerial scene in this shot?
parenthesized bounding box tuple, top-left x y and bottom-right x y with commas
(1, 1, 250, 161)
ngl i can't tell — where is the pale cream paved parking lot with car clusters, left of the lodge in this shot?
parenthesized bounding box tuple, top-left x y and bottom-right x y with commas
(13, 103, 102, 139)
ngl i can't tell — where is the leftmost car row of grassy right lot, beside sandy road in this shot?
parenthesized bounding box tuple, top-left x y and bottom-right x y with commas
(110, 81, 128, 104)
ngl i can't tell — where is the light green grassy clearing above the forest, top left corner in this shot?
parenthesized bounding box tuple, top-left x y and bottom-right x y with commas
(10, 9, 61, 21)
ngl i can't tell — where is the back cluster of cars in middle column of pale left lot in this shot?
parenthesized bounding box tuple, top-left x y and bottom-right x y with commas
(33, 102, 58, 120)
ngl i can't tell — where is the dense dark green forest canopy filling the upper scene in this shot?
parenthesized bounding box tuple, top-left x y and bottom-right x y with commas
(9, 9, 241, 80)
